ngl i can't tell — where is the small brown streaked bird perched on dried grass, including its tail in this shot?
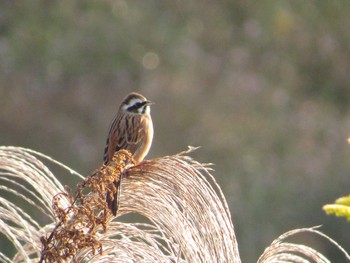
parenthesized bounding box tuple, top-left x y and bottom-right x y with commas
(103, 92, 154, 216)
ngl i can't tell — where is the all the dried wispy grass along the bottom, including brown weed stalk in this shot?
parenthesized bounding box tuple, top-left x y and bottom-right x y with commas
(0, 147, 350, 262)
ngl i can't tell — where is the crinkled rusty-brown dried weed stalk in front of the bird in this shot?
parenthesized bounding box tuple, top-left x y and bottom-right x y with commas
(39, 150, 131, 262)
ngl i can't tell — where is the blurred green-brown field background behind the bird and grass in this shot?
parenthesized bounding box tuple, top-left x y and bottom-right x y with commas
(0, 0, 350, 262)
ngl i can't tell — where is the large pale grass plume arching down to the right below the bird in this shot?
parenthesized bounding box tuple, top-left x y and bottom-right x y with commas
(115, 153, 240, 262)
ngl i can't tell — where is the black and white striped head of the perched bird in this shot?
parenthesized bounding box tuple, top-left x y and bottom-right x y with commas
(120, 92, 153, 114)
